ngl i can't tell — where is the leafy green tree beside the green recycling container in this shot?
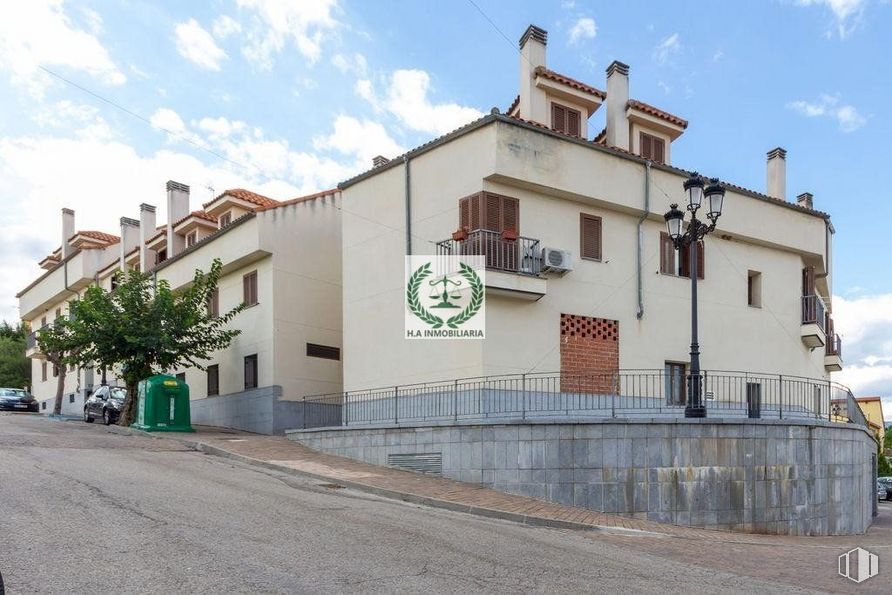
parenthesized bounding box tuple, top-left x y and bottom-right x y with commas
(38, 259, 245, 425)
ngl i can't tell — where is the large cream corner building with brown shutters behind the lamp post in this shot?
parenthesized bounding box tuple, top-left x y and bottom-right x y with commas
(339, 26, 842, 399)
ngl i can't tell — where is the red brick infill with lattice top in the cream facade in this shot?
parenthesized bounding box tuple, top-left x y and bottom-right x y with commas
(561, 314, 619, 394)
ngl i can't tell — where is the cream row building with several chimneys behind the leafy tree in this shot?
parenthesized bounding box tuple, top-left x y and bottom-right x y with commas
(18, 182, 341, 433)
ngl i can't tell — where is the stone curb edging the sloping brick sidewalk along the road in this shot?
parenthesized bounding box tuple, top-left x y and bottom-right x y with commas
(106, 425, 668, 537)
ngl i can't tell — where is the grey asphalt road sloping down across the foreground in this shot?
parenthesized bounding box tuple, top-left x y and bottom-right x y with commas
(0, 413, 852, 594)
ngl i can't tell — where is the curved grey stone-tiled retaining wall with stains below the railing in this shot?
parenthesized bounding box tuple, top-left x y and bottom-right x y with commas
(287, 420, 876, 535)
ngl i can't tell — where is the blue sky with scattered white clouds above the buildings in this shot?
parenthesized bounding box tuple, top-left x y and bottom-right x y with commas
(0, 0, 892, 420)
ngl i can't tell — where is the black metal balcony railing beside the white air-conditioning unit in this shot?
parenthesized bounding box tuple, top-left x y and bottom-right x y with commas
(437, 229, 542, 276)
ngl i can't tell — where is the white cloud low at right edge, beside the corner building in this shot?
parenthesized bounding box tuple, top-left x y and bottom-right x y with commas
(833, 294, 892, 410)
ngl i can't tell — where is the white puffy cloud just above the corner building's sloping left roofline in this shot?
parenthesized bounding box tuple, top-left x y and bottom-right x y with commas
(355, 70, 483, 134)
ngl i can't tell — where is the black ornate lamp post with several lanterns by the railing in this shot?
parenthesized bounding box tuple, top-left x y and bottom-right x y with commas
(664, 172, 725, 417)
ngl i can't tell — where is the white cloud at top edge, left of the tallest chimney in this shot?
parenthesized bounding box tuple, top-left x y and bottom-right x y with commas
(237, 0, 339, 70)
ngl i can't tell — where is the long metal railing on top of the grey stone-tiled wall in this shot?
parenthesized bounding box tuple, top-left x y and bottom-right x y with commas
(303, 370, 863, 428)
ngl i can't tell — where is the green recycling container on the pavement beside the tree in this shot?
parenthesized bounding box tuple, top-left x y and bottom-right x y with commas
(131, 375, 195, 432)
